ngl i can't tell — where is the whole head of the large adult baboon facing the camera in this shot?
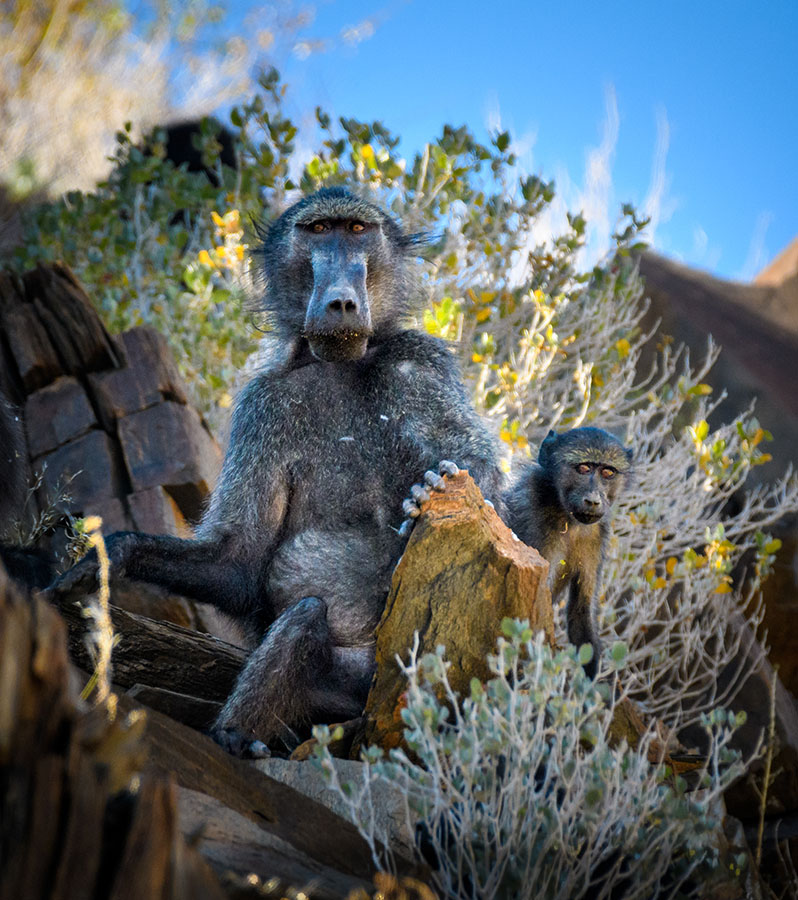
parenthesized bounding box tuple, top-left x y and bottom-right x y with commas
(262, 188, 418, 362)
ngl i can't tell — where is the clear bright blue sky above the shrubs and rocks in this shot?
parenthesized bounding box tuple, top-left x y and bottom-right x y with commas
(248, 0, 798, 279)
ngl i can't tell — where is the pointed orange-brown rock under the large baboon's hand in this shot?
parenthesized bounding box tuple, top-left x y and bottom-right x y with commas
(364, 472, 554, 750)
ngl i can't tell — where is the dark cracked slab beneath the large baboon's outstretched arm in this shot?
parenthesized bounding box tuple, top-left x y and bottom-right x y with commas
(55, 600, 246, 702)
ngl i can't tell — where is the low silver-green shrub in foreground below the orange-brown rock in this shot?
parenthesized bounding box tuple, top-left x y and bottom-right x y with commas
(315, 620, 744, 900)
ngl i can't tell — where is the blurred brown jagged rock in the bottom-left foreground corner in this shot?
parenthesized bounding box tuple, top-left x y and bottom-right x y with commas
(0, 567, 231, 900)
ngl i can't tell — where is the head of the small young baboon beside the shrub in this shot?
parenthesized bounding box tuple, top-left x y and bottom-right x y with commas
(538, 428, 631, 525)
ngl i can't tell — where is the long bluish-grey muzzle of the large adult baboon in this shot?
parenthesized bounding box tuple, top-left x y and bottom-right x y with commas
(305, 248, 372, 362)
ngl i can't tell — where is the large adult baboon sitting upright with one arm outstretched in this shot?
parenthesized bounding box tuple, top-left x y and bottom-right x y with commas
(57, 188, 501, 750)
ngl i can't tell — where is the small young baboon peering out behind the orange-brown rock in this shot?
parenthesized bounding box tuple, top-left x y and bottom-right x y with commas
(504, 428, 632, 678)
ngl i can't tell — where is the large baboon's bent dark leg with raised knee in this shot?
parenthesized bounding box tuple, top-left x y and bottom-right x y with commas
(212, 597, 373, 756)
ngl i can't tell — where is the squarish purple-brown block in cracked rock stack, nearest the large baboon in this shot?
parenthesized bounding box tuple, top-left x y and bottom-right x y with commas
(118, 402, 221, 520)
